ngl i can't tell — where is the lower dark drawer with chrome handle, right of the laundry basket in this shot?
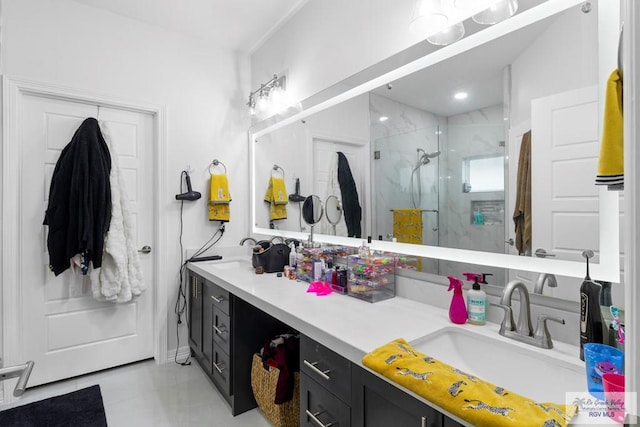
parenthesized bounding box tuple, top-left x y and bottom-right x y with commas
(300, 373, 351, 427)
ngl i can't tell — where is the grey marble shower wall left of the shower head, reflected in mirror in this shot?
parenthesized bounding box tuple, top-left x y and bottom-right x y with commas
(370, 94, 446, 272)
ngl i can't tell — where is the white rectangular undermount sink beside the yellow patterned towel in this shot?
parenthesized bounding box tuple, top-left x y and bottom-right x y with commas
(410, 327, 587, 403)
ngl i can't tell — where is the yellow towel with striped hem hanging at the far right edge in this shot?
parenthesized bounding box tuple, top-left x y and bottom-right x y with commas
(596, 69, 624, 190)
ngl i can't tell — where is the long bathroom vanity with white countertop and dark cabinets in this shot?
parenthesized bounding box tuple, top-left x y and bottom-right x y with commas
(188, 259, 583, 427)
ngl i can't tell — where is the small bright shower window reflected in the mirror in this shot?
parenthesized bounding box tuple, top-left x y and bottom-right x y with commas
(462, 156, 504, 193)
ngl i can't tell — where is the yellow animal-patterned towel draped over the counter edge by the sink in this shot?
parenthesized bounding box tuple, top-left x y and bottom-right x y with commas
(362, 338, 577, 427)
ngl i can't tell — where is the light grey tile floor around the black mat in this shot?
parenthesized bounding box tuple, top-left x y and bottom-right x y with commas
(0, 360, 271, 427)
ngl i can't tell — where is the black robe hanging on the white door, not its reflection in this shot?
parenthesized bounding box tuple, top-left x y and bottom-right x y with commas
(44, 118, 111, 276)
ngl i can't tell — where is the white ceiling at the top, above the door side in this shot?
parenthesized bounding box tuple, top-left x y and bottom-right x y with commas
(74, 0, 308, 52)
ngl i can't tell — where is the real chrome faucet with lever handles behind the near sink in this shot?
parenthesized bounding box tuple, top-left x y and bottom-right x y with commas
(492, 280, 564, 348)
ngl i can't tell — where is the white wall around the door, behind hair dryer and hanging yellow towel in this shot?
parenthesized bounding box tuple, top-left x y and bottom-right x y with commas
(0, 0, 249, 362)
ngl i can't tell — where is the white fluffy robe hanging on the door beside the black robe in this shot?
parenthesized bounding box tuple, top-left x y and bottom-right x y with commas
(91, 122, 146, 303)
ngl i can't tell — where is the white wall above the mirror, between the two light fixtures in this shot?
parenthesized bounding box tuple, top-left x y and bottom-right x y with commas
(251, 0, 419, 108)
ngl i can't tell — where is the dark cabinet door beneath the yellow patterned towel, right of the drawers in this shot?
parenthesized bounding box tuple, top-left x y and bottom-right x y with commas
(351, 365, 443, 427)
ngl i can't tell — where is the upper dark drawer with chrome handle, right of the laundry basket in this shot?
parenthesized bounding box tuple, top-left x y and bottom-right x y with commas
(300, 335, 351, 404)
